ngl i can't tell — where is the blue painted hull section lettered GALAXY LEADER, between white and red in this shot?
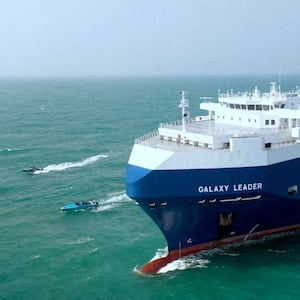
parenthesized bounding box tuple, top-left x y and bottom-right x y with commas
(126, 159, 300, 272)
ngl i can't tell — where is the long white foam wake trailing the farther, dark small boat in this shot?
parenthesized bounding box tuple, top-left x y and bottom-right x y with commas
(33, 154, 108, 174)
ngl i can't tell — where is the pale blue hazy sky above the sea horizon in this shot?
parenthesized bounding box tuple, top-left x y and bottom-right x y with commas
(0, 0, 300, 76)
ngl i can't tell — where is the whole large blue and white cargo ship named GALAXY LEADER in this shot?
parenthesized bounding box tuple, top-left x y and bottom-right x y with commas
(126, 82, 300, 274)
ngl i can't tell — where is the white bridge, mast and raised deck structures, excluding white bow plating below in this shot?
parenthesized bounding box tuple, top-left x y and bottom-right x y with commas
(159, 82, 300, 149)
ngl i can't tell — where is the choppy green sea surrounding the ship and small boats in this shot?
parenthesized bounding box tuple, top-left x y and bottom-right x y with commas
(0, 76, 300, 300)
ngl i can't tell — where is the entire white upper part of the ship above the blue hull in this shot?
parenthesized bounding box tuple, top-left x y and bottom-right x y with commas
(130, 82, 300, 169)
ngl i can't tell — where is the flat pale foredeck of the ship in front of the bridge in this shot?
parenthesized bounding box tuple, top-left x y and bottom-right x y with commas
(135, 120, 297, 151)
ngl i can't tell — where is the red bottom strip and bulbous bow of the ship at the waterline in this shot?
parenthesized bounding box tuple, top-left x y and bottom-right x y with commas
(140, 224, 300, 274)
